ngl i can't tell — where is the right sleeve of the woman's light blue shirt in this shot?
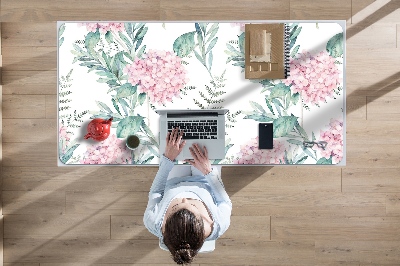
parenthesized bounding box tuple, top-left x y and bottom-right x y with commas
(205, 167, 232, 238)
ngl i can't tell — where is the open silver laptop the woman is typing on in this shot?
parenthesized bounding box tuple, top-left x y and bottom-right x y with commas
(156, 109, 228, 160)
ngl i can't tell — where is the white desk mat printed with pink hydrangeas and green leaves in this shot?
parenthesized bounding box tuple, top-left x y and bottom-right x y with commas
(58, 21, 345, 165)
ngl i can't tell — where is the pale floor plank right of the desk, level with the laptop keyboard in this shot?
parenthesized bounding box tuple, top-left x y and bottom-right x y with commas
(346, 119, 400, 145)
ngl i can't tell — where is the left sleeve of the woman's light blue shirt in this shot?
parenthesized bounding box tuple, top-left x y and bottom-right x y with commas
(143, 155, 174, 236)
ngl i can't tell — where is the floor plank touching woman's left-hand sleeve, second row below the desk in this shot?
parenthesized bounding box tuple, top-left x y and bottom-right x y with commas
(66, 191, 148, 215)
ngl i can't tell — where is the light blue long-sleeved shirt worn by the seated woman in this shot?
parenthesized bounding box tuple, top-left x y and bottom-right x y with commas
(143, 155, 232, 240)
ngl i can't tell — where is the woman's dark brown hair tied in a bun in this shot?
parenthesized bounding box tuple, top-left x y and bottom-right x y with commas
(163, 209, 205, 264)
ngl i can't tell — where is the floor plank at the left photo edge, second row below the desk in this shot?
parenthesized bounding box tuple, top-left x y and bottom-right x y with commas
(3, 191, 65, 215)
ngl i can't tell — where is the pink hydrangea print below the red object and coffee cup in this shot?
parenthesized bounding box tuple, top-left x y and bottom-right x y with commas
(80, 135, 132, 164)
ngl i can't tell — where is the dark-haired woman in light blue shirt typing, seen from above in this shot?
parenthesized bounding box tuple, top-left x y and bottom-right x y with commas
(143, 128, 232, 264)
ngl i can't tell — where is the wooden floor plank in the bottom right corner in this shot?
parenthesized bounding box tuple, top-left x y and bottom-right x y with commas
(315, 240, 400, 265)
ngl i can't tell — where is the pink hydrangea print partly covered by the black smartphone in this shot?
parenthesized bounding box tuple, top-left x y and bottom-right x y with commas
(234, 137, 286, 164)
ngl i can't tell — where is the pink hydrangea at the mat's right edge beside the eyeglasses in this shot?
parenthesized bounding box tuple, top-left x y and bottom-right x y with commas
(318, 119, 343, 164)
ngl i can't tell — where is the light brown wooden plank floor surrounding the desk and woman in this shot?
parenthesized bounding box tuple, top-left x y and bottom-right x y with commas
(0, 0, 400, 266)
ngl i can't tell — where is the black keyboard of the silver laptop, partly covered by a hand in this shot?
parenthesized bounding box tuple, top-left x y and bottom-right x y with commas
(168, 120, 217, 139)
